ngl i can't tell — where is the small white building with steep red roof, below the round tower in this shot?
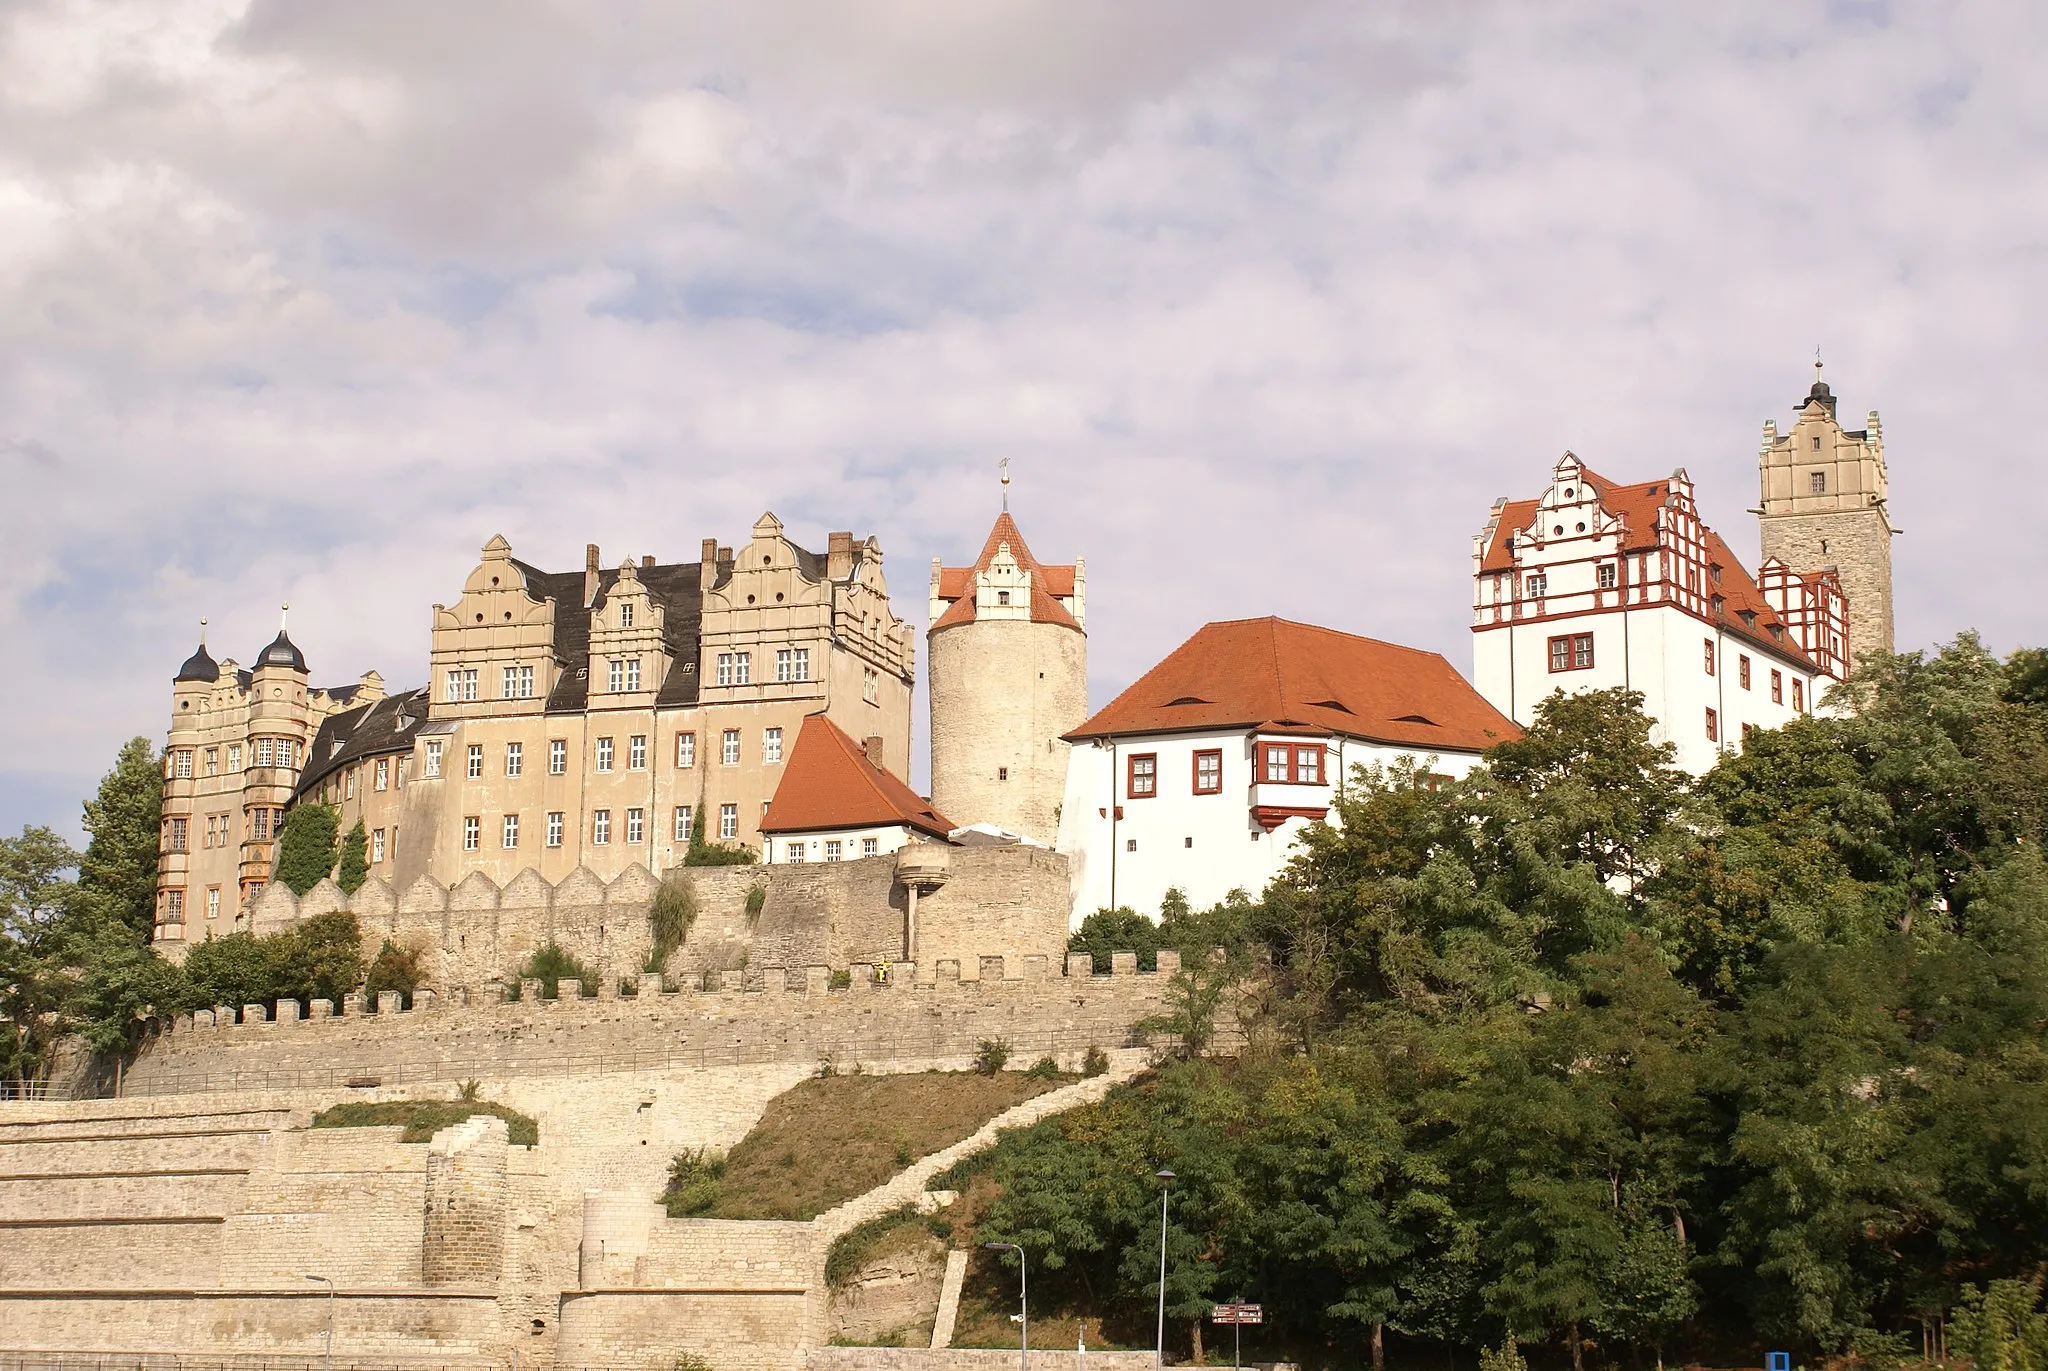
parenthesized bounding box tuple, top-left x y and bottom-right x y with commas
(762, 713, 952, 865)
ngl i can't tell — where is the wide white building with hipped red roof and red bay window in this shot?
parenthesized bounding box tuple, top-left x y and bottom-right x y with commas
(1059, 619, 1520, 920)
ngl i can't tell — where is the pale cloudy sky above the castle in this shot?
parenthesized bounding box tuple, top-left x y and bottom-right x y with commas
(0, 0, 2048, 836)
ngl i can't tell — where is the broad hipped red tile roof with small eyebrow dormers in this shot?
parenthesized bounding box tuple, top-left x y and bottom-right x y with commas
(1067, 619, 1522, 752)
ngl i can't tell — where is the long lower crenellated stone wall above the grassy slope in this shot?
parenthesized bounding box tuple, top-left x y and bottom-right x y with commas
(121, 951, 1180, 1096)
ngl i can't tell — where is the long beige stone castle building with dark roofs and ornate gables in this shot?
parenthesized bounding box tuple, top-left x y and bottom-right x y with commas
(158, 514, 915, 943)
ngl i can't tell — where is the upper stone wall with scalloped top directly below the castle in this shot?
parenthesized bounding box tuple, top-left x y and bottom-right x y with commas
(252, 844, 1071, 992)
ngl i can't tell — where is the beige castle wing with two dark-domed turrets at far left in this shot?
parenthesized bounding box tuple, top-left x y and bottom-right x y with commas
(156, 625, 385, 943)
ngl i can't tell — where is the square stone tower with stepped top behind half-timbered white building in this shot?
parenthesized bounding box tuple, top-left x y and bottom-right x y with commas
(1757, 363, 1896, 670)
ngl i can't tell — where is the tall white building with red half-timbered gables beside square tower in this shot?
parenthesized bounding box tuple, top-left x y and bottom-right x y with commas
(1473, 453, 1849, 775)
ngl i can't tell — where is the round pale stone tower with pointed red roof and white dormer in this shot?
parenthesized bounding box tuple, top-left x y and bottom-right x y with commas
(930, 508, 1087, 846)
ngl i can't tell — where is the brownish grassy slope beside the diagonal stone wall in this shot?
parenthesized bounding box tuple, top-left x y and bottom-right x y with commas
(709, 1072, 1071, 1219)
